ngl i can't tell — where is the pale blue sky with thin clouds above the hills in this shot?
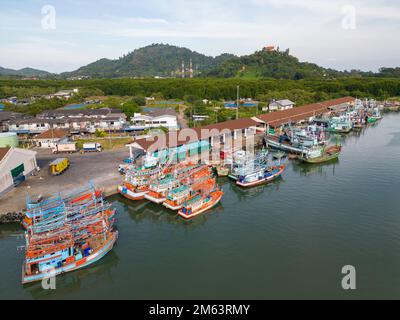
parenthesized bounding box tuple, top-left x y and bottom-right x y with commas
(0, 0, 400, 73)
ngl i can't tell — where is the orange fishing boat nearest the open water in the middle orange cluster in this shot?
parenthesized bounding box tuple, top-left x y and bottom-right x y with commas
(178, 187, 224, 219)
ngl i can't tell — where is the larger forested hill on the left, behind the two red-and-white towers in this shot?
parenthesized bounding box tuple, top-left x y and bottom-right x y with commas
(61, 44, 234, 78)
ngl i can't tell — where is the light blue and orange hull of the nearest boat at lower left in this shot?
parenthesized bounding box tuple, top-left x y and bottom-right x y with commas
(22, 231, 118, 284)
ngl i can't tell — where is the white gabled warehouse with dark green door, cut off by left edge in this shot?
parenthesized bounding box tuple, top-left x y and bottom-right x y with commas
(0, 148, 38, 197)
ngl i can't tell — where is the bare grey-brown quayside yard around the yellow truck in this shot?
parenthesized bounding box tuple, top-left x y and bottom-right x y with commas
(0, 148, 129, 215)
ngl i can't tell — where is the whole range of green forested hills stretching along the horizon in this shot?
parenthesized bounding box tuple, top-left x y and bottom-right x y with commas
(0, 43, 400, 80)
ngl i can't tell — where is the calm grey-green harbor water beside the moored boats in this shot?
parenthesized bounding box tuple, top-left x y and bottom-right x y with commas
(0, 113, 400, 299)
